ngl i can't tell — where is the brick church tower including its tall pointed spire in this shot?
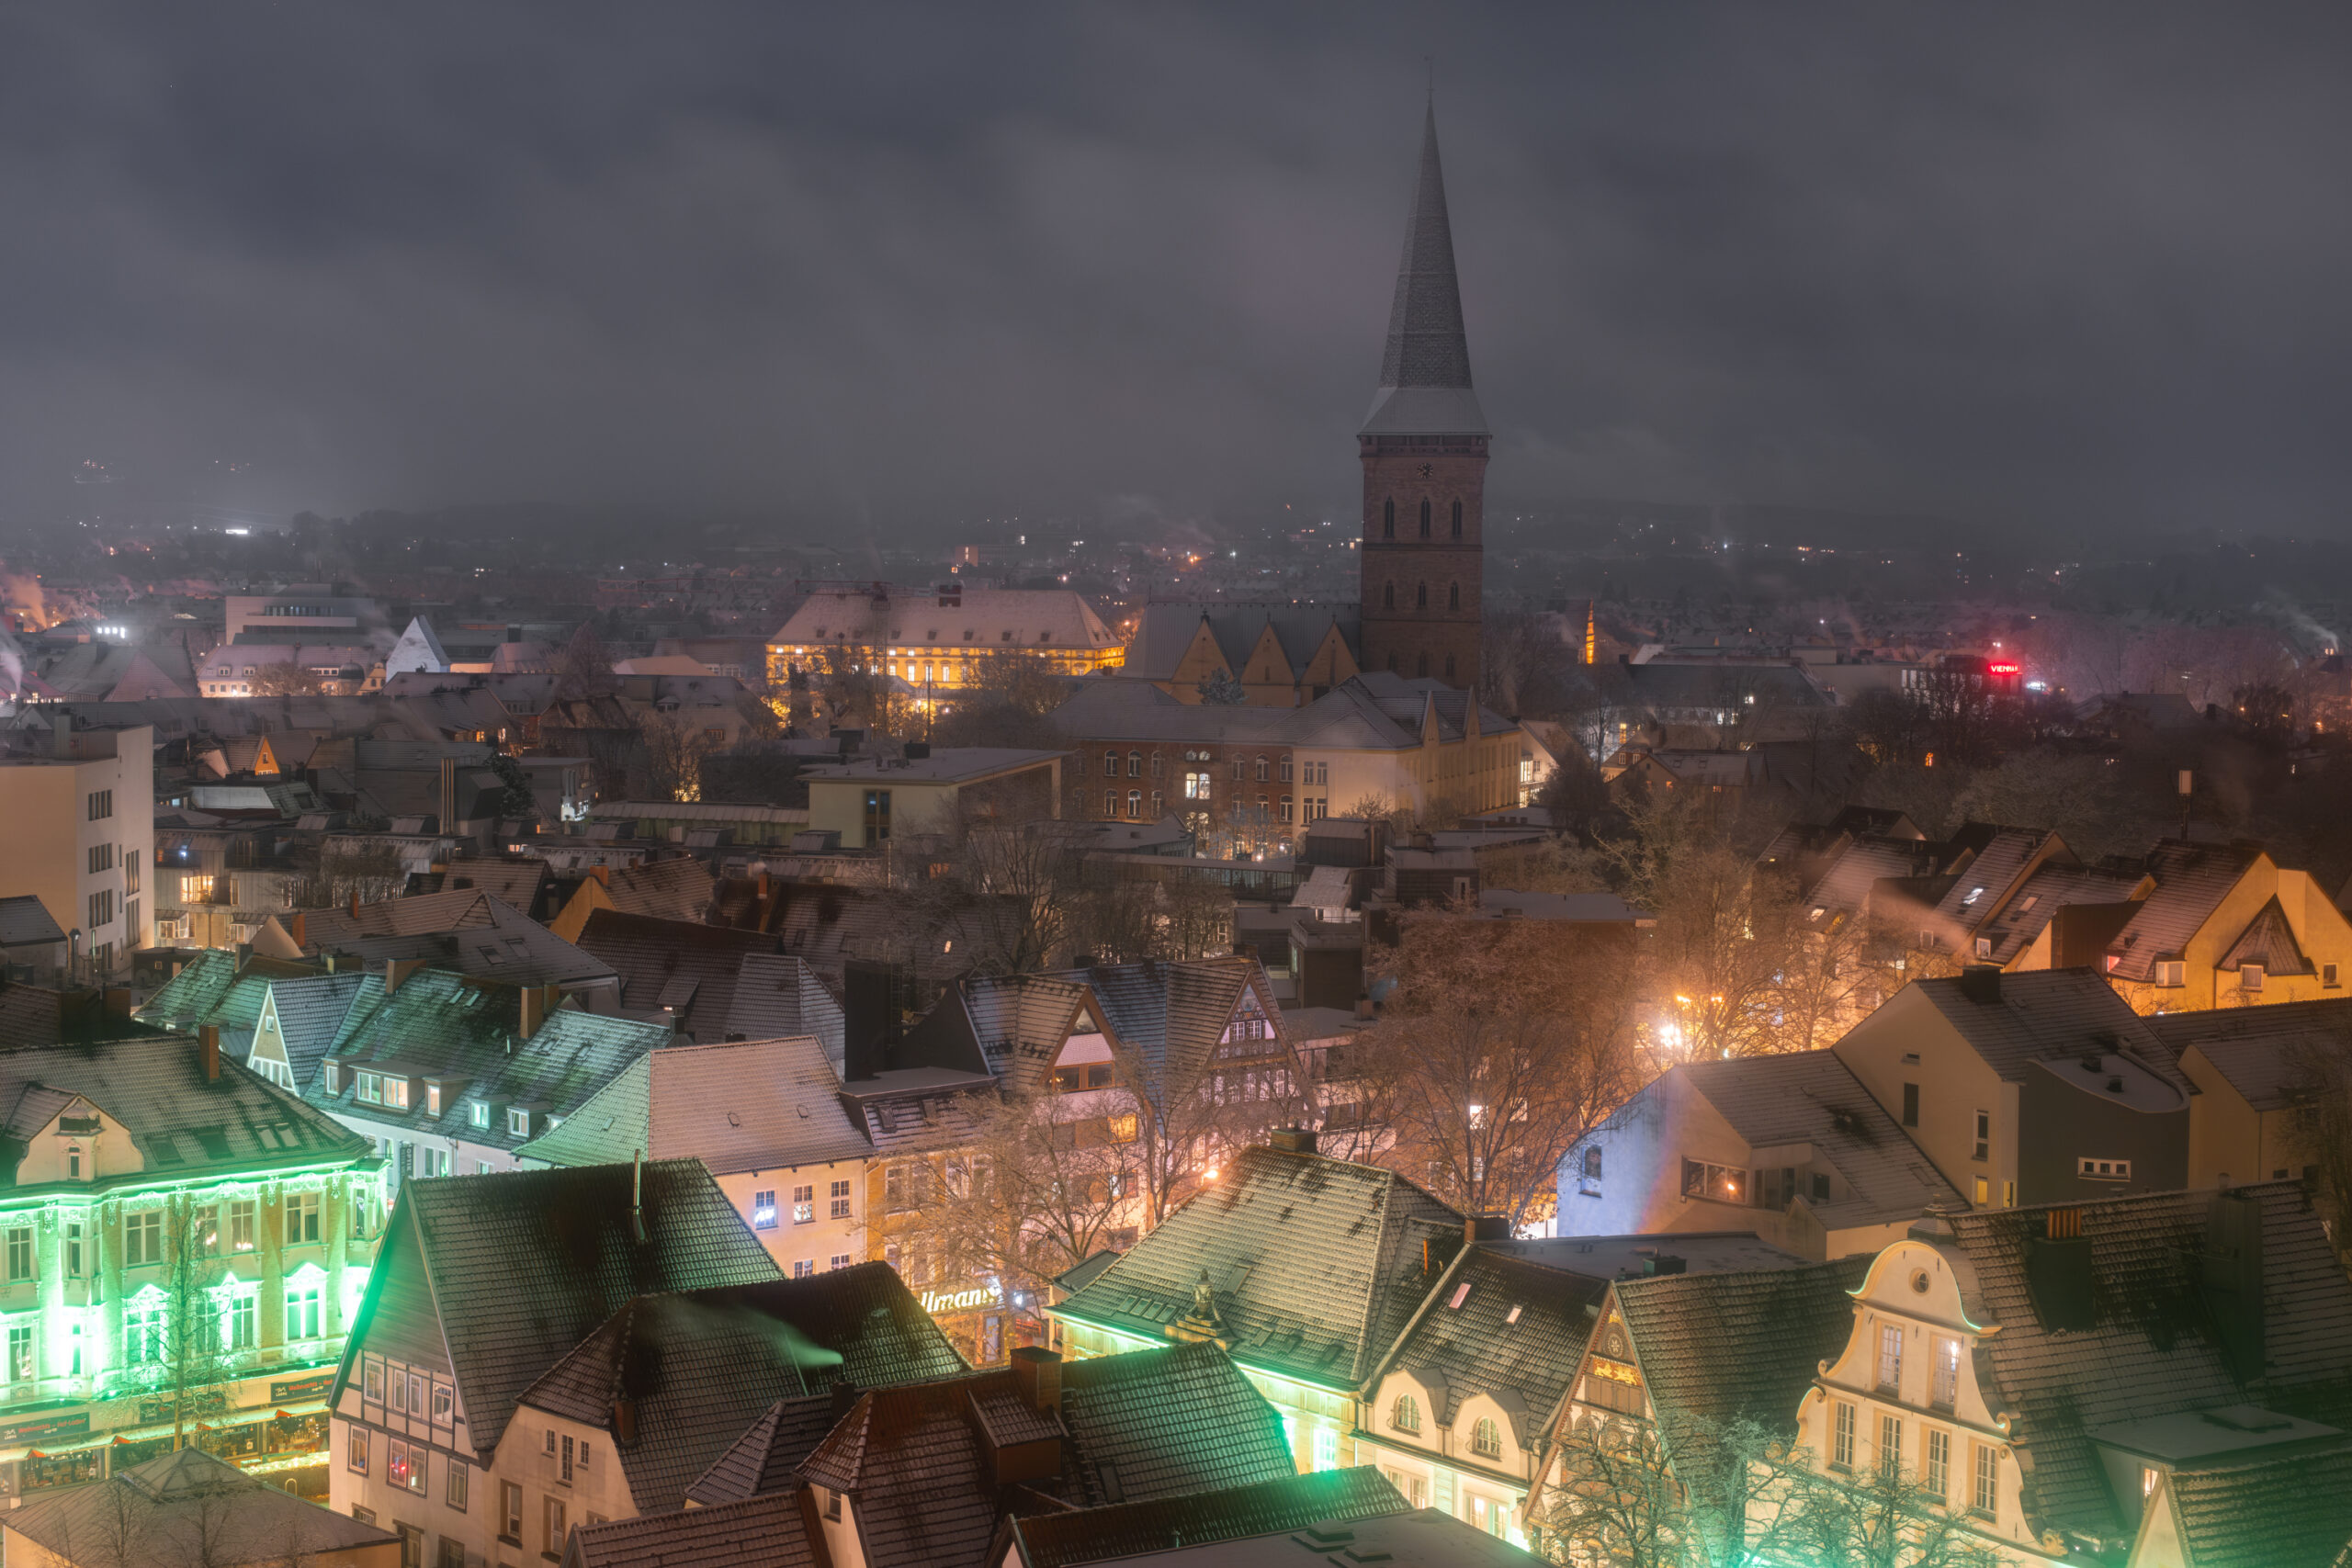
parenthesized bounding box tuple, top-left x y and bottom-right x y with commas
(1355, 108, 1487, 691)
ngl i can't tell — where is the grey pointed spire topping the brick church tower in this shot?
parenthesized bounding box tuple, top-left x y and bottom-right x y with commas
(1364, 101, 1487, 434)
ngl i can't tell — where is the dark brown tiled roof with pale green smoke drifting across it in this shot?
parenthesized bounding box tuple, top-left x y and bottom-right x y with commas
(515, 1262, 967, 1514)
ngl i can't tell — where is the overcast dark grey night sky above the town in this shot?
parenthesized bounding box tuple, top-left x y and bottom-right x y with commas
(0, 0, 2352, 534)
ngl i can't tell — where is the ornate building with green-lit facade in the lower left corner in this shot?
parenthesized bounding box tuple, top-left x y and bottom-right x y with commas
(0, 1034, 374, 1497)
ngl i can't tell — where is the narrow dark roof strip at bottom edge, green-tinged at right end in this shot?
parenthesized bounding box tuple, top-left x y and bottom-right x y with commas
(990, 1464, 1407, 1568)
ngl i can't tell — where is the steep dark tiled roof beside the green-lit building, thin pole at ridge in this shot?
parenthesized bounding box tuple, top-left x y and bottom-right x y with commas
(343, 1159, 778, 1485)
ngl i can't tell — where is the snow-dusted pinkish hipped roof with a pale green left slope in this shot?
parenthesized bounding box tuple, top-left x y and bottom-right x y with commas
(515, 1034, 873, 1176)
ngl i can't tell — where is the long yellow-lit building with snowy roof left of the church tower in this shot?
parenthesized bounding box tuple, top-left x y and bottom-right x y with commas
(767, 583, 1126, 694)
